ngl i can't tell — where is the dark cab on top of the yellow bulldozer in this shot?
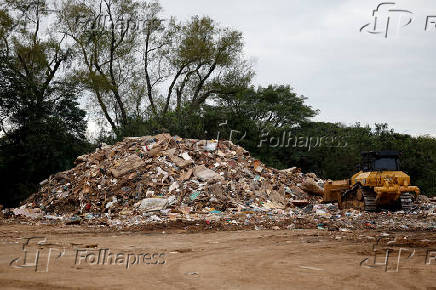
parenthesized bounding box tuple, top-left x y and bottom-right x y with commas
(360, 151, 400, 172)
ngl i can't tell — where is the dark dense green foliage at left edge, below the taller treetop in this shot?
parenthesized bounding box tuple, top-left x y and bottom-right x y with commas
(0, 53, 90, 206)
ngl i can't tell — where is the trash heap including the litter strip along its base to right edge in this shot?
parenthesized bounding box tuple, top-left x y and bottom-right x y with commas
(3, 134, 436, 231)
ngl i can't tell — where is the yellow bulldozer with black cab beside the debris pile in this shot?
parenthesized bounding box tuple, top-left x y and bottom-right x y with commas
(324, 151, 420, 211)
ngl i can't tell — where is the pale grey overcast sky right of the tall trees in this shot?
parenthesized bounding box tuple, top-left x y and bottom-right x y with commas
(161, 0, 436, 136)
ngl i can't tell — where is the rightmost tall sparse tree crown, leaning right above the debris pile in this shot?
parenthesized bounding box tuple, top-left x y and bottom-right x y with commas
(168, 16, 253, 112)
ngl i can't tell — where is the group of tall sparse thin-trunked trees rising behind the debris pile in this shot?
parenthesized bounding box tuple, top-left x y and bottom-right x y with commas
(58, 0, 252, 134)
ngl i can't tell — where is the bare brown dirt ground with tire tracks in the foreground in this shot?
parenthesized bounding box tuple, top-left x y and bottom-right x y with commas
(0, 224, 436, 289)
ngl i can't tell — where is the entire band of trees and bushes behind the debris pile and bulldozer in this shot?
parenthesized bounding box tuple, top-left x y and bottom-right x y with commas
(0, 0, 436, 206)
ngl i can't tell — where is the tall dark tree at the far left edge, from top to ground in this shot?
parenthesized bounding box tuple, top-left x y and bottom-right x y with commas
(0, 1, 88, 206)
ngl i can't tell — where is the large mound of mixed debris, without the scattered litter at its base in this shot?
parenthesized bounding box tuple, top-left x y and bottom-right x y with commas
(8, 134, 323, 225)
